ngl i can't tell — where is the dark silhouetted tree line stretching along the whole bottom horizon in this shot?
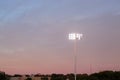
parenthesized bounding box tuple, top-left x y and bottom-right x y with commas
(0, 71, 120, 80)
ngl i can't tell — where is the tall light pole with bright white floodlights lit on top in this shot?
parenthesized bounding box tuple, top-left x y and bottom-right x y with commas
(69, 33, 83, 80)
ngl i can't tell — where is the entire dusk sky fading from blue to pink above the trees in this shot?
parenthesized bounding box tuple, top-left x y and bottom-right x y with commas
(0, 0, 120, 74)
